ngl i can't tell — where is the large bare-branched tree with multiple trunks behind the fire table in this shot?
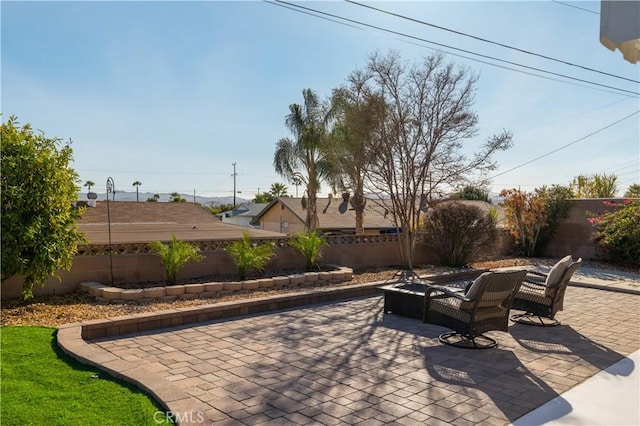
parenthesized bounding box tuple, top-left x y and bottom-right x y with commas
(366, 52, 512, 269)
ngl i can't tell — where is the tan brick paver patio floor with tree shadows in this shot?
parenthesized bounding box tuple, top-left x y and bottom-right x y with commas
(57, 287, 640, 425)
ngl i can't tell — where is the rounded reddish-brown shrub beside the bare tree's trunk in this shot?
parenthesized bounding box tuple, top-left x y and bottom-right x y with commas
(424, 201, 497, 266)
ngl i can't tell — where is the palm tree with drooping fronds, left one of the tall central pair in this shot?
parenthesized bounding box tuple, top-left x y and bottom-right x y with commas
(273, 89, 331, 231)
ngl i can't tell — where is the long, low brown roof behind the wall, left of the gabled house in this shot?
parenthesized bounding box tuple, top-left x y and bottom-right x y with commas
(78, 201, 286, 244)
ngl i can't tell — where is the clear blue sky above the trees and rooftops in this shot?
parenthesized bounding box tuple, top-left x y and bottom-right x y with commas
(1, 1, 640, 198)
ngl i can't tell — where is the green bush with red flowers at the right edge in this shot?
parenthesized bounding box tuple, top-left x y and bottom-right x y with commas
(587, 200, 640, 265)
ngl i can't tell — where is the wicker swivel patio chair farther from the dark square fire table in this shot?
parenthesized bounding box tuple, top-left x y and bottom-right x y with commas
(511, 256, 582, 327)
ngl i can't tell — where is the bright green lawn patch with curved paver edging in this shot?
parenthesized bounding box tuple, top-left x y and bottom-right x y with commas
(0, 327, 170, 426)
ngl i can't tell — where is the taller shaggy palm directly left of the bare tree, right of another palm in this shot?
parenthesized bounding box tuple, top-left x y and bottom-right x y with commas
(330, 78, 386, 235)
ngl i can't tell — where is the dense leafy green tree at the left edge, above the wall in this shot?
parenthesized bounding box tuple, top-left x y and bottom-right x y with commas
(1, 116, 83, 299)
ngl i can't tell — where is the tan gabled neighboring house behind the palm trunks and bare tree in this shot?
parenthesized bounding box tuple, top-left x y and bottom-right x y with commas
(254, 197, 397, 235)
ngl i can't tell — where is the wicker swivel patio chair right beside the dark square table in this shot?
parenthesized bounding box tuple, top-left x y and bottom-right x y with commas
(422, 270, 527, 349)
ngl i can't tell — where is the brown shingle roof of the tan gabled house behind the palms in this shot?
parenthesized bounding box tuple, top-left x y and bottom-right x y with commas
(257, 197, 395, 229)
